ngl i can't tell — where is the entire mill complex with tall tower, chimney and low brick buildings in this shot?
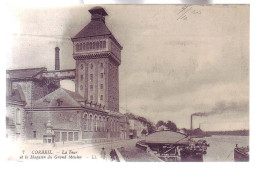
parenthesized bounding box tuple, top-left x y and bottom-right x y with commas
(6, 7, 129, 143)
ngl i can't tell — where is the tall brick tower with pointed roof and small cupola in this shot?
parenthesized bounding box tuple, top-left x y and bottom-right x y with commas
(72, 7, 122, 111)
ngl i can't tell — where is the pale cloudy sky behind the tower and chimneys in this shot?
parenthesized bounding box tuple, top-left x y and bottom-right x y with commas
(7, 5, 249, 130)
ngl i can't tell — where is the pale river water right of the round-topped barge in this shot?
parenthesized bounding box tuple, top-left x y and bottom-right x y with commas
(199, 135, 249, 162)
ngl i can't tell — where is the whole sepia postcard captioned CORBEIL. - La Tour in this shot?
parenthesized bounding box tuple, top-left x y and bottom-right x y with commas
(5, 4, 250, 162)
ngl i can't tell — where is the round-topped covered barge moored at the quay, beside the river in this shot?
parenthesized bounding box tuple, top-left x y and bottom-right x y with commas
(136, 131, 208, 162)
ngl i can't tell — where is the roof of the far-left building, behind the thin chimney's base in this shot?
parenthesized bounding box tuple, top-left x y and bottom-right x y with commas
(6, 67, 47, 79)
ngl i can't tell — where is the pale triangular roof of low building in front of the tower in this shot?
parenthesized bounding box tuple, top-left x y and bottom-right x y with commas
(33, 88, 83, 108)
